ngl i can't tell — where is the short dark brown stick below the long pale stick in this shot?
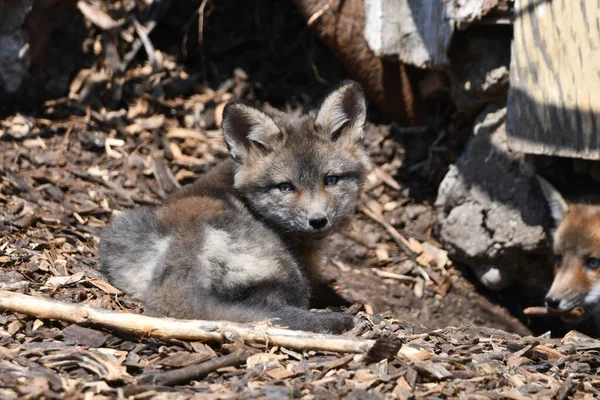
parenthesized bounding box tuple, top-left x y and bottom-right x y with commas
(142, 350, 251, 386)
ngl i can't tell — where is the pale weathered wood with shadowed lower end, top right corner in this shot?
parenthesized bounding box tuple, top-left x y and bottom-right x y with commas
(507, 0, 600, 160)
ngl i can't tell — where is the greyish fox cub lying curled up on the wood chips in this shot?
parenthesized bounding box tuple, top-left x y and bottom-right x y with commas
(100, 82, 369, 333)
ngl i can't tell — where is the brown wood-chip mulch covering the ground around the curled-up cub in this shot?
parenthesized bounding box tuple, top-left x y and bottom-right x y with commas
(0, 2, 600, 399)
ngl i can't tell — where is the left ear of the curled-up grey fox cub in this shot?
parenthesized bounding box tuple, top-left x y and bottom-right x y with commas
(222, 102, 284, 162)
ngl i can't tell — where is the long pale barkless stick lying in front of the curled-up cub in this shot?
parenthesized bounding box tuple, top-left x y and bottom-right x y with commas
(0, 290, 376, 354)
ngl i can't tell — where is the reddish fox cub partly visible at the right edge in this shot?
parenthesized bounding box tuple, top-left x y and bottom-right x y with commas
(538, 177, 600, 322)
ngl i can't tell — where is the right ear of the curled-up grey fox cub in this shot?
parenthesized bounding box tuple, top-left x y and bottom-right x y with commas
(315, 81, 367, 144)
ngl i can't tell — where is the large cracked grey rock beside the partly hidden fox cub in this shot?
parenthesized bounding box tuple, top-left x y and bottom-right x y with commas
(435, 106, 552, 296)
